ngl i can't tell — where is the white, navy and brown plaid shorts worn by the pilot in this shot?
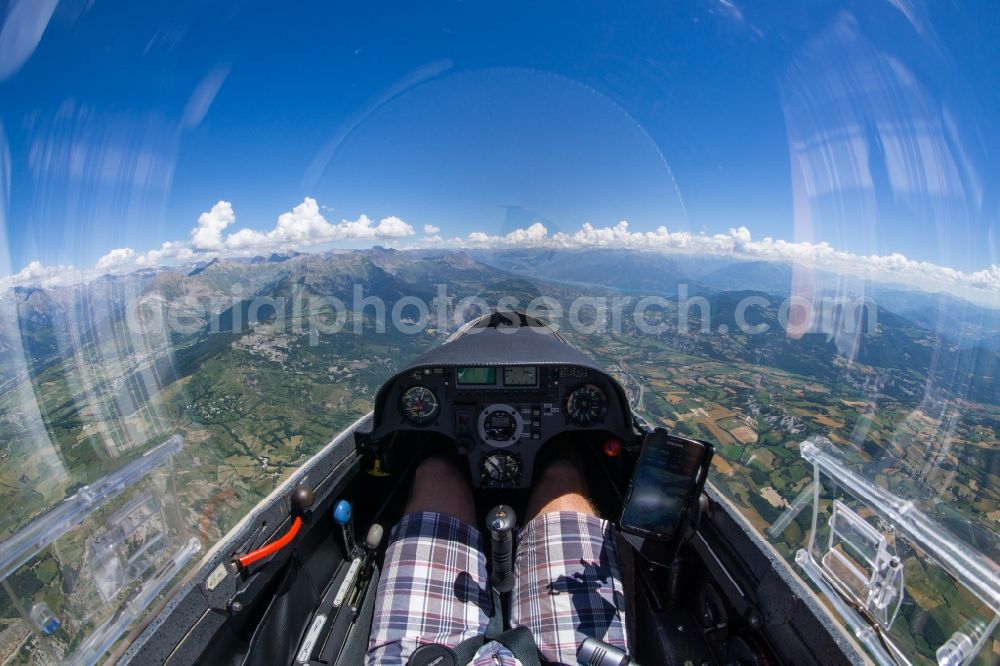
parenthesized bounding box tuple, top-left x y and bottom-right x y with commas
(367, 511, 626, 666)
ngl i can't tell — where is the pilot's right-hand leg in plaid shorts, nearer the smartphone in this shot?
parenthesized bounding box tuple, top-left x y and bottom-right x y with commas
(511, 460, 627, 664)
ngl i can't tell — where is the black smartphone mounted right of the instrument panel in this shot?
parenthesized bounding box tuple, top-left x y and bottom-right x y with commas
(618, 428, 713, 541)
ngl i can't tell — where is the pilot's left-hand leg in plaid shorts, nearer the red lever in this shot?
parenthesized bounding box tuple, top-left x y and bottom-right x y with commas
(366, 458, 491, 664)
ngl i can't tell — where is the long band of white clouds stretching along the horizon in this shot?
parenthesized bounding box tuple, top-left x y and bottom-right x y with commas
(0, 197, 1000, 305)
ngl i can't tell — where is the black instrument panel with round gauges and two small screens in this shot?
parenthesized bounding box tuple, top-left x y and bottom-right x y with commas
(375, 365, 630, 488)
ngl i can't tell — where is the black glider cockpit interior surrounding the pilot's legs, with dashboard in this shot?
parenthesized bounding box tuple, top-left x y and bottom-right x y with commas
(126, 312, 849, 666)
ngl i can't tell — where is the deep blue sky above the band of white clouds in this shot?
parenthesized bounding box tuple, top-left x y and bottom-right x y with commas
(0, 0, 1000, 294)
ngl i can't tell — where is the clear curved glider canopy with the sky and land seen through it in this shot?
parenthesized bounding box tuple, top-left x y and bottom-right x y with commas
(0, 0, 1000, 664)
